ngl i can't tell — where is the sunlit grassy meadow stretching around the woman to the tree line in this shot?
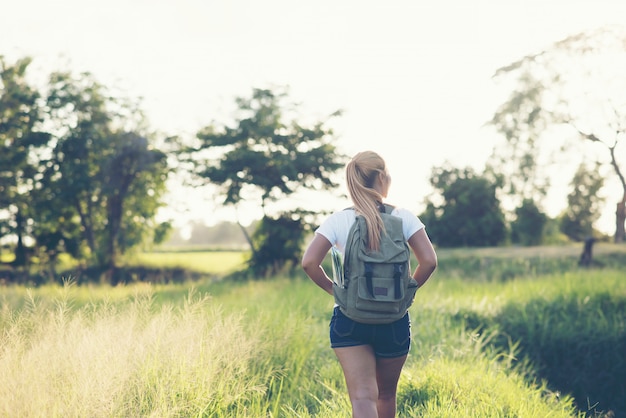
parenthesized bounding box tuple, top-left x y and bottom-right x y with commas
(0, 247, 626, 418)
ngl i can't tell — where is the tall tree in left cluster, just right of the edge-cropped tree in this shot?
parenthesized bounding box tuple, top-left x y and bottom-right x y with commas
(46, 72, 113, 265)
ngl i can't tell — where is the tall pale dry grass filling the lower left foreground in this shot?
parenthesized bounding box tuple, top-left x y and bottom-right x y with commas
(0, 287, 272, 417)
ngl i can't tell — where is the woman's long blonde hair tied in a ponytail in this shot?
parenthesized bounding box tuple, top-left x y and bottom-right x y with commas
(346, 151, 386, 251)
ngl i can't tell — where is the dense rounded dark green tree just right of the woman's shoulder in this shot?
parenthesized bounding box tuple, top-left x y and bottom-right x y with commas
(420, 165, 506, 247)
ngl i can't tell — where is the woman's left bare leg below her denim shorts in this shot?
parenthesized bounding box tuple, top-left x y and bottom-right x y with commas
(334, 345, 378, 418)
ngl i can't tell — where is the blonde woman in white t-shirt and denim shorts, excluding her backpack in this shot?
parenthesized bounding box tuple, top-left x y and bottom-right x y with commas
(302, 151, 437, 418)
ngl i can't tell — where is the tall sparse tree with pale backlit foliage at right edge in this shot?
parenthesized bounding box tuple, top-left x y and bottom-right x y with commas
(492, 27, 626, 242)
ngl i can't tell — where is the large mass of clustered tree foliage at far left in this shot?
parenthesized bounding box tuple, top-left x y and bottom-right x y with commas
(0, 58, 169, 277)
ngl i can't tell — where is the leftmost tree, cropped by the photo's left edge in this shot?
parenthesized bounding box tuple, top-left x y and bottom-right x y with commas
(0, 56, 50, 266)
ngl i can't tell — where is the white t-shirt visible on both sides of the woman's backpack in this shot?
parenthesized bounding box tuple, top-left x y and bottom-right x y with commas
(315, 208, 424, 254)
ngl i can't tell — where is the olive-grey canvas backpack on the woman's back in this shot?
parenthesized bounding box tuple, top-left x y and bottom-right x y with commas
(333, 204, 418, 324)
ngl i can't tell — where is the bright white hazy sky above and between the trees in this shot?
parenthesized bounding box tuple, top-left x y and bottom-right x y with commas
(0, 0, 626, 231)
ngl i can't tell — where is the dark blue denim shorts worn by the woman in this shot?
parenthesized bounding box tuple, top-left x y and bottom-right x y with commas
(330, 306, 411, 358)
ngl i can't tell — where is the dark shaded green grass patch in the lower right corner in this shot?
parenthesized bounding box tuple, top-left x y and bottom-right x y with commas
(448, 271, 626, 411)
